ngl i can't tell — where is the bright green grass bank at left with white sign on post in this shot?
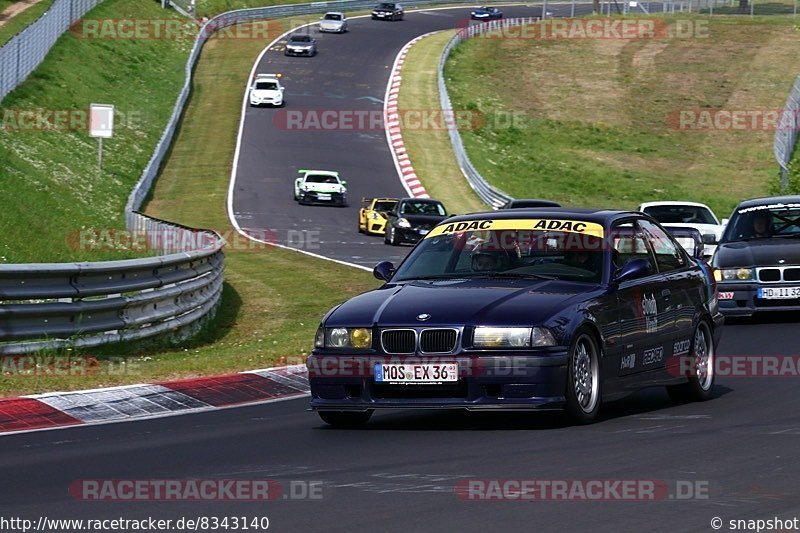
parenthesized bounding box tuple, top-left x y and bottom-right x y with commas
(0, 0, 191, 263)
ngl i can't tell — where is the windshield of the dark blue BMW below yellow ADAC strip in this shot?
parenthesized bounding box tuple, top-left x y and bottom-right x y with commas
(392, 225, 603, 283)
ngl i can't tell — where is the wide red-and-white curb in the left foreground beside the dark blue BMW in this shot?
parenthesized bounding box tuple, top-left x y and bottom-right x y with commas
(0, 365, 309, 434)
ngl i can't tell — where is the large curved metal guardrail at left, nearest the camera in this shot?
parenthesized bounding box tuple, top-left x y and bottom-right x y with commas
(0, 213, 224, 354)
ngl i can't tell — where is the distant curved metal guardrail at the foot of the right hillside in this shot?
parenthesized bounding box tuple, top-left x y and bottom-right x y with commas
(438, 18, 538, 209)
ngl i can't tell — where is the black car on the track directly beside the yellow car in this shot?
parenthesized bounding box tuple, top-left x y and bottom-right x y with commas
(383, 198, 448, 246)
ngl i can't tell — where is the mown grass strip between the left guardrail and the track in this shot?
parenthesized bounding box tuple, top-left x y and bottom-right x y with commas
(0, 18, 378, 395)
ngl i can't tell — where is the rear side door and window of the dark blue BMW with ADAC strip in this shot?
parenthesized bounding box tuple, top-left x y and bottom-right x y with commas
(639, 220, 704, 372)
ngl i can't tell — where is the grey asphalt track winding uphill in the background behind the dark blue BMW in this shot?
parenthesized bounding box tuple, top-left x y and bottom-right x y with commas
(233, 5, 591, 268)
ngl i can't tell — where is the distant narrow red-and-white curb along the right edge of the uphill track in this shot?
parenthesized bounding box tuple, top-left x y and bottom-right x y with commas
(383, 32, 436, 198)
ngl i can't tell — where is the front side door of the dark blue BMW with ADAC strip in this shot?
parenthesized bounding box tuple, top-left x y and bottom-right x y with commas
(610, 219, 673, 376)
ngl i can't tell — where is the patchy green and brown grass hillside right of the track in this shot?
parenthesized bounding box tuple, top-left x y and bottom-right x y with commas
(446, 14, 800, 216)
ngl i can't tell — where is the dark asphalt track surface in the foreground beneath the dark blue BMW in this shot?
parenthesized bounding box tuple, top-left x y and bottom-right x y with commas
(0, 316, 800, 531)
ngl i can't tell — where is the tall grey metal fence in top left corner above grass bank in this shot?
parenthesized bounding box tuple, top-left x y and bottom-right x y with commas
(0, 0, 102, 101)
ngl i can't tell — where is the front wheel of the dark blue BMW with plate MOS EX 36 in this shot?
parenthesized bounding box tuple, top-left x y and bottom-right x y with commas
(565, 329, 602, 424)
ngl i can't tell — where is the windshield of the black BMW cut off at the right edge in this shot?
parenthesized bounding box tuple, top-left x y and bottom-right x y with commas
(720, 204, 800, 242)
